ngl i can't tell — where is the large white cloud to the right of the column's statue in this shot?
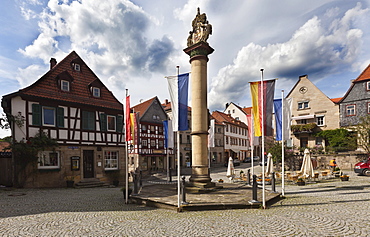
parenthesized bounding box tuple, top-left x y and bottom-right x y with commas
(209, 4, 369, 108)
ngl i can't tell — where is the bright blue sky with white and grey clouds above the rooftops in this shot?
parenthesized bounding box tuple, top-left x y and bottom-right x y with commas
(0, 0, 370, 137)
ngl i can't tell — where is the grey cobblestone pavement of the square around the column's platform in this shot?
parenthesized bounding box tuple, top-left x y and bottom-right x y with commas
(0, 168, 370, 236)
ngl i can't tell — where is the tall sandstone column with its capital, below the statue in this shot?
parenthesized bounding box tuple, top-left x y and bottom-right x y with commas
(184, 41, 214, 186)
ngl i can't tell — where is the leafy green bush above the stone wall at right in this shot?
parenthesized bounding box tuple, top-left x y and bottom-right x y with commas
(315, 128, 357, 151)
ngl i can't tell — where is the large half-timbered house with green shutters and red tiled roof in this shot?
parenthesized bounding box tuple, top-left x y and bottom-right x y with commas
(2, 51, 125, 187)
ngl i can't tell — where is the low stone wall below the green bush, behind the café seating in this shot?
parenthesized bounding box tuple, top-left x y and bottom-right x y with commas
(311, 153, 367, 170)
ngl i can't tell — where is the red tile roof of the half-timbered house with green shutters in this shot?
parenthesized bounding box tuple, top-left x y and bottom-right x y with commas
(3, 51, 123, 110)
